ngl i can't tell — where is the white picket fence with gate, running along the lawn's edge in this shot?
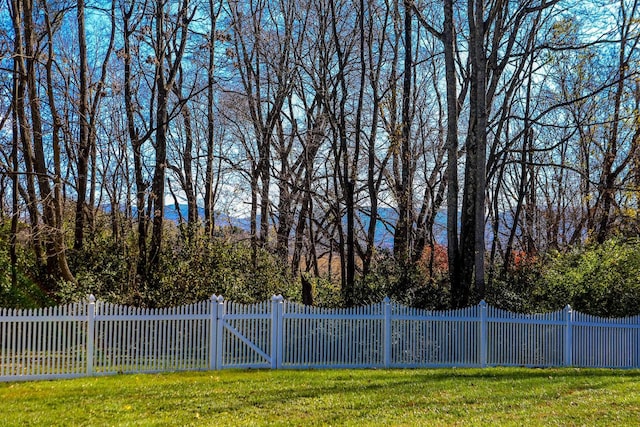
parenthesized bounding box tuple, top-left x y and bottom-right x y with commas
(0, 295, 640, 381)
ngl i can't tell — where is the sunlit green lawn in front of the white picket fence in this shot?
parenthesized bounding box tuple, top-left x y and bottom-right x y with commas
(0, 368, 640, 426)
